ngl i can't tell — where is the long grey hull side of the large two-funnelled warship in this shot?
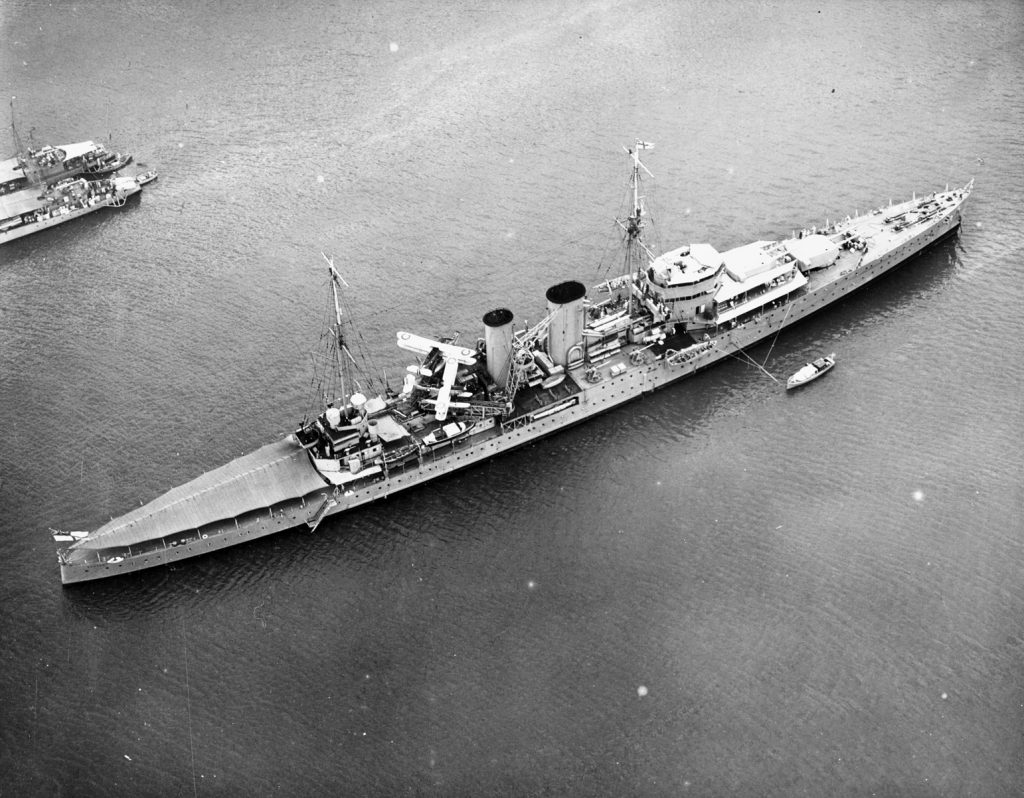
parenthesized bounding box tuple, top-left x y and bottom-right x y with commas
(60, 191, 961, 584)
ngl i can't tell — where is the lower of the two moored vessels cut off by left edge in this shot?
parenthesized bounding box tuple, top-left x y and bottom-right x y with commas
(0, 171, 158, 244)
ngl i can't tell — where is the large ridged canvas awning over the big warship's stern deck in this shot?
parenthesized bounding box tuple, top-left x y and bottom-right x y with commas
(71, 438, 326, 549)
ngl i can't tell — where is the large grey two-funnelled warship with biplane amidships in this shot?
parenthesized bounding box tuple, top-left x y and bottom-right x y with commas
(51, 140, 973, 584)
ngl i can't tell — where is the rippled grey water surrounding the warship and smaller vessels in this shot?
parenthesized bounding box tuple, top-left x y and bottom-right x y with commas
(0, 0, 1024, 796)
